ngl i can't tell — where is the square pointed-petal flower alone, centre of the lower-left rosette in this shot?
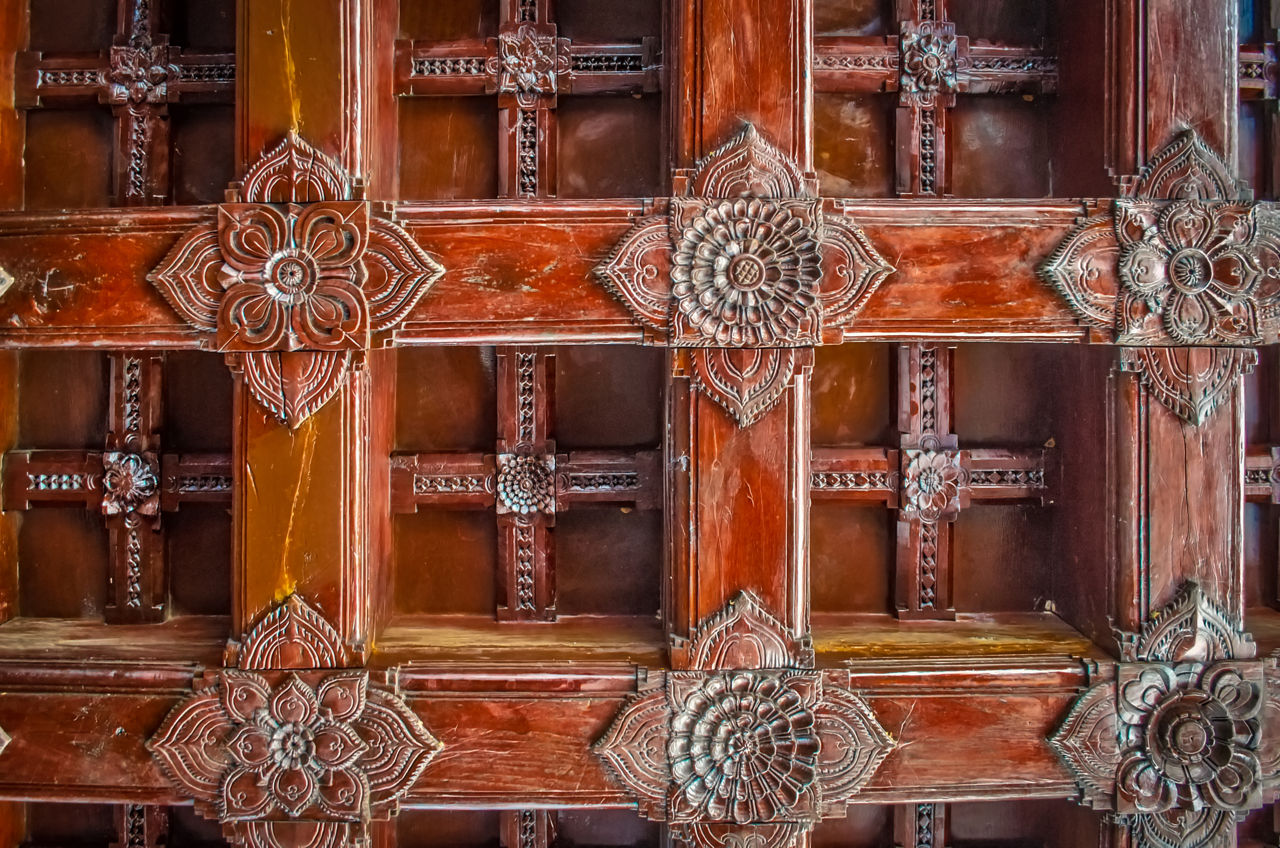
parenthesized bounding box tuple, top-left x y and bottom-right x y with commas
(221, 673, 369, 820)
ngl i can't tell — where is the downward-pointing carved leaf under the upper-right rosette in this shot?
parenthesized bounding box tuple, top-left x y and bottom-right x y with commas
(1120, 347, 1258, 427)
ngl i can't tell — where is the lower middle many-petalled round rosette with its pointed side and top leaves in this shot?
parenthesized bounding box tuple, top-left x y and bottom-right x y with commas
(595, 593, 896, 835)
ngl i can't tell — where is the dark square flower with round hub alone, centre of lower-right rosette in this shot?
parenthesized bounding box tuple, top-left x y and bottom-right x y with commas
(1116, 662, 1262, 812)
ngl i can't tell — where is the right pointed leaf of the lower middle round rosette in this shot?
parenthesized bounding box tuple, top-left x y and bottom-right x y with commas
(814, 685, 897, 812)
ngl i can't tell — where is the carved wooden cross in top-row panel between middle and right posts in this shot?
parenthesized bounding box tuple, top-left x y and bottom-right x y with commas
(813, 0, 1057, 196)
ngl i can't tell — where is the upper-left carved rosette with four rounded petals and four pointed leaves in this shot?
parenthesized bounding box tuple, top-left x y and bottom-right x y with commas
(147, 133, 444, 427)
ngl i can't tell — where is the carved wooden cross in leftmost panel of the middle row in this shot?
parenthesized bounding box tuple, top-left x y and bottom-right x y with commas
(4, 354, 232, 624)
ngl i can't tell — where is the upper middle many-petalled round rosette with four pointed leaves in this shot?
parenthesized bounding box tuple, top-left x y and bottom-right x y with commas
(595, 124, 893, 427)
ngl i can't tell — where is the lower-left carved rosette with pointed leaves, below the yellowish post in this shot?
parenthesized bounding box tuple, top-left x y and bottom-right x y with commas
(147, 596, 442, 847)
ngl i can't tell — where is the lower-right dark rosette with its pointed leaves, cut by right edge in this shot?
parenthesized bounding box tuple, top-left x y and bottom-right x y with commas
(1050, 583, 1280, 848)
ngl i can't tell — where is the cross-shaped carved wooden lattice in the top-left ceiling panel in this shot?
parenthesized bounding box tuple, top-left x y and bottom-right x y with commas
(15, 0, 236, 205)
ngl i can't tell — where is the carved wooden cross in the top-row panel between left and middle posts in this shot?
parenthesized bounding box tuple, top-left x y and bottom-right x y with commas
(396, 0, 662, 197)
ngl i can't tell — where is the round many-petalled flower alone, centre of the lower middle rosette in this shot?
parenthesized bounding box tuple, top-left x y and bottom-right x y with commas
(667, 671, 819, 822)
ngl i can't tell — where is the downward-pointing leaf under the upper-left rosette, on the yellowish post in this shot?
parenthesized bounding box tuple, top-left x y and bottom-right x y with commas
(232, 351, 357, 428)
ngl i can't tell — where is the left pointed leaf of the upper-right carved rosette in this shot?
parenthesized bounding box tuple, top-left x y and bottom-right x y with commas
(1036, 213, 1120, 333)
